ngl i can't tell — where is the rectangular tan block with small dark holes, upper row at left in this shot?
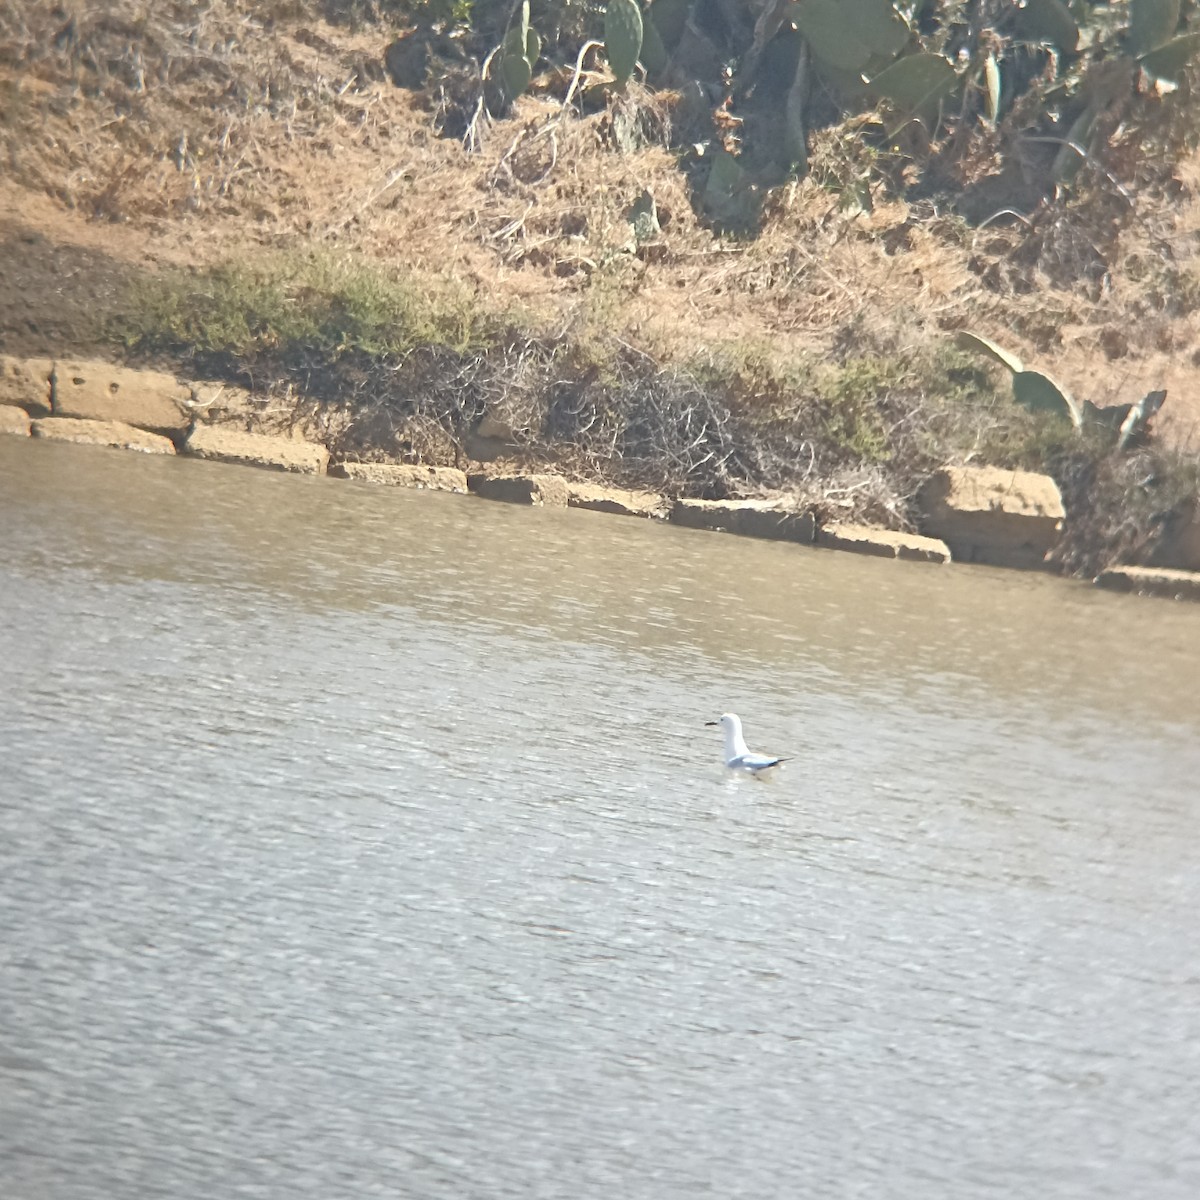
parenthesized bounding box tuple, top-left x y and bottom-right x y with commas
(50, 360, 192, 440)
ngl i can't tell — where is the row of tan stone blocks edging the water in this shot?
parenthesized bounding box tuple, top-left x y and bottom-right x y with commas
(0, 355, 1200, 600)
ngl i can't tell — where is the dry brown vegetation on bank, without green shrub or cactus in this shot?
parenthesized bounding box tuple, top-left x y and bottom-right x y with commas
(0, 0, 1200, 570)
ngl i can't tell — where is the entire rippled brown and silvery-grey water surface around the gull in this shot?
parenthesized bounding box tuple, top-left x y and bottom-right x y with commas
(0, 439, 1200, 1200)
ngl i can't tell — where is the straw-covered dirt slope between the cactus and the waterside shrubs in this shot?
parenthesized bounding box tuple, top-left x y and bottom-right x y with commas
(0, 0, 1200, 450)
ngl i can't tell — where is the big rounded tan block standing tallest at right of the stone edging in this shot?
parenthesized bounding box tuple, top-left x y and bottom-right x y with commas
(917, 467, 1066, 568)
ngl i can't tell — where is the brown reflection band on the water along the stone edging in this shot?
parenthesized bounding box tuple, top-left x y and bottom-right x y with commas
(0, 436, 1200, 719)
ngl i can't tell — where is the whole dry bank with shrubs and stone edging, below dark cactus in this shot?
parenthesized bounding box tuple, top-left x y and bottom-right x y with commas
(7, 0, 1200, 594)
